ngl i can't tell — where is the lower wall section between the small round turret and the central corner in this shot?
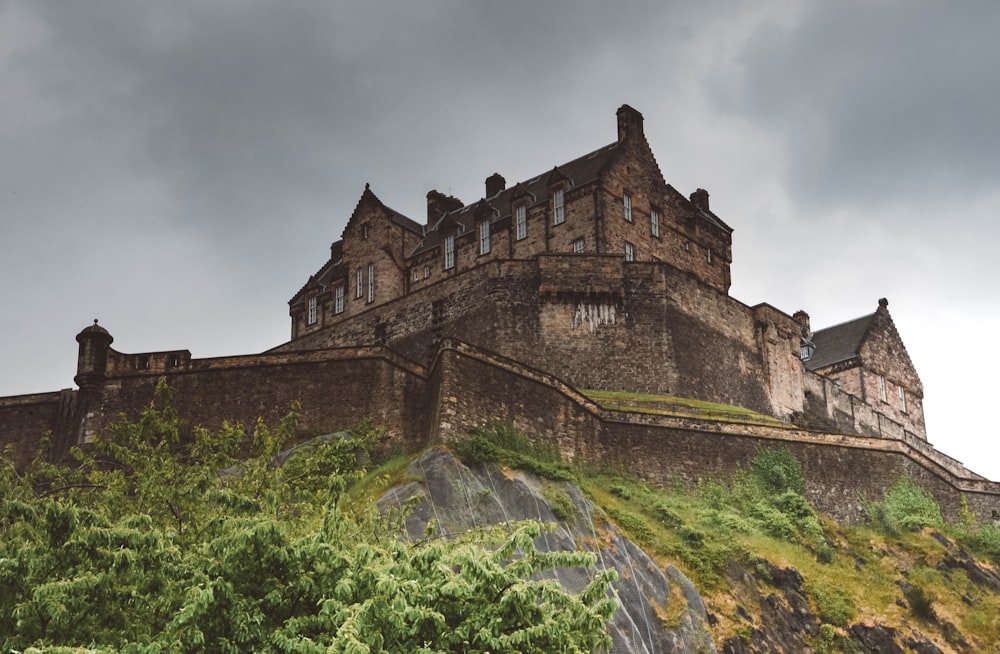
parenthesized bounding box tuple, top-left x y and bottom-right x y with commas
(76, 348, 428, 454)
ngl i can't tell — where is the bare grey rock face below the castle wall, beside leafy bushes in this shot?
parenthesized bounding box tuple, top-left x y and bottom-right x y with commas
(379, 450, 717, 654)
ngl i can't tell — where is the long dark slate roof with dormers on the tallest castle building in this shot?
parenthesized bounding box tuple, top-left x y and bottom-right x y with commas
(408, 141, 620, 256)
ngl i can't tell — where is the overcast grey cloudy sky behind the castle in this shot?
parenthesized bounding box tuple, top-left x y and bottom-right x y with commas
(0, 0, 1000, 480)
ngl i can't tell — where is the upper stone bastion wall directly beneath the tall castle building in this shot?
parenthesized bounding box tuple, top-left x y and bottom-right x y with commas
(274, 254, 802, 416)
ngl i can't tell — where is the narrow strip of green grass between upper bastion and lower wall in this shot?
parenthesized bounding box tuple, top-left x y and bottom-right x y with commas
(580, 389, 793, 429)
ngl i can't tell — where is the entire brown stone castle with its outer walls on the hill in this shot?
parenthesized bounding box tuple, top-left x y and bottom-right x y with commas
(0, 105, 1000, 519)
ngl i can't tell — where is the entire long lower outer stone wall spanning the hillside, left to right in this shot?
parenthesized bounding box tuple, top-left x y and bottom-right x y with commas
(0, 338, 1000, 520)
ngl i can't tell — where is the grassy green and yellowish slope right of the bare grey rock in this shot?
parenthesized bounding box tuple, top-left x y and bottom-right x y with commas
(456, 426, 1000, 651)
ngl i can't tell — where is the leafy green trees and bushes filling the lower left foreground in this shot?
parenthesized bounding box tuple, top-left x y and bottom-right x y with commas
(0, 386, 615, 653)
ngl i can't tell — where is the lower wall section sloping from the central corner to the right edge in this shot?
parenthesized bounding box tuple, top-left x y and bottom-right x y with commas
(435, 342, 1000, 521)
